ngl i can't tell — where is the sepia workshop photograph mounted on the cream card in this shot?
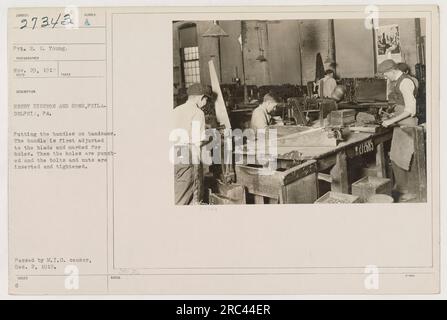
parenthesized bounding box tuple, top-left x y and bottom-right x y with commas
(173, 18, 427, 205)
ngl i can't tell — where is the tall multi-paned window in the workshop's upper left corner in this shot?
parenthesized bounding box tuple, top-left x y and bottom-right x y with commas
(179, 24, 200, 88)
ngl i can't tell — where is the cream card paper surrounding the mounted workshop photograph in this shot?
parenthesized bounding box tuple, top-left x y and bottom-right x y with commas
(8, 6, 440, 294)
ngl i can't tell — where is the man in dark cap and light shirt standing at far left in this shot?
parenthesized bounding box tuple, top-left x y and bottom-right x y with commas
(174, 83, 213, 205)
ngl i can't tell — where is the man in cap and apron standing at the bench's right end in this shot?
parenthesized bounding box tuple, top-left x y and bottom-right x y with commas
(378, 59, 418, 202)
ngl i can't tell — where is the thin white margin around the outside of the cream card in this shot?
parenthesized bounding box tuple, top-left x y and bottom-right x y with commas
(0, 0, 447, 300)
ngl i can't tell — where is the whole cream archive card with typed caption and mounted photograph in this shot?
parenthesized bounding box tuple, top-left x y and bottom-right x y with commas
(6, 3, 445, 296)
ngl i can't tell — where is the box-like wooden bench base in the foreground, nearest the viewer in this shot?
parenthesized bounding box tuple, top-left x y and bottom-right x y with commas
(236, 160, 318, 203)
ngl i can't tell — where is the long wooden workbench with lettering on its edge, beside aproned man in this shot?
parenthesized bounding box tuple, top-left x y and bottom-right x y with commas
(236, 126, 393, 203)
